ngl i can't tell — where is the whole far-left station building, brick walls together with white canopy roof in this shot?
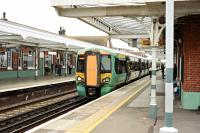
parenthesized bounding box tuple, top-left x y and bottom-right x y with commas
(0, 20, 98, 79)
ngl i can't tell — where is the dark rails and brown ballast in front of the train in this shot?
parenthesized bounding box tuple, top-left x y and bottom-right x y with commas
(0, 75, 149, 133)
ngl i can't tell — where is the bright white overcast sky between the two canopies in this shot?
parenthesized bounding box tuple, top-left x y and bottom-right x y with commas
(0, 0, 128, 47)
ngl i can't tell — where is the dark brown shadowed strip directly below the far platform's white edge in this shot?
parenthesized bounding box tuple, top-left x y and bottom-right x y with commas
(0, 81, 75, 108)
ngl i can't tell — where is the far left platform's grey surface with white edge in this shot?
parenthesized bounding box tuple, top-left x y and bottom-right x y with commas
(0, 75, 75, 93)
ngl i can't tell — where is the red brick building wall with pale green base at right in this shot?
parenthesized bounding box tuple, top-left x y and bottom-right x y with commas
(174, 15, 200, 109)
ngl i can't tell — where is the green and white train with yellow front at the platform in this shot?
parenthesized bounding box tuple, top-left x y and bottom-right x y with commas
(76, 48, 151, 97)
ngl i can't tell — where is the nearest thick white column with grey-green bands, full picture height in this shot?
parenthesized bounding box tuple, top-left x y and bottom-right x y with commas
(160, 0, 178, 133)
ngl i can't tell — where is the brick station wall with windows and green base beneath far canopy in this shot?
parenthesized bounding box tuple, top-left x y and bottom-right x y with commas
(0, 44, 75, 79)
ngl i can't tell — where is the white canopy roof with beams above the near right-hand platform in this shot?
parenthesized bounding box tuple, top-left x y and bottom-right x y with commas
(51, 0, 200, 43)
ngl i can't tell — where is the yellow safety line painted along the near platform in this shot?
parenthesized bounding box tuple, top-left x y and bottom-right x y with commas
(83, 82, 149, 133)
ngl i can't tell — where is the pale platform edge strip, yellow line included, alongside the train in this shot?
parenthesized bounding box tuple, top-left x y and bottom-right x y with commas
(28, 77, 150, 133)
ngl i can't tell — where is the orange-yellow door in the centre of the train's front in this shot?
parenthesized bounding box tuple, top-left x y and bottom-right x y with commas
(86, 52, 100, 87)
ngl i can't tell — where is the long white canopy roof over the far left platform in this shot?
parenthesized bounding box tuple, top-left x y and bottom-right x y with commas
(0, 20, 103, 52)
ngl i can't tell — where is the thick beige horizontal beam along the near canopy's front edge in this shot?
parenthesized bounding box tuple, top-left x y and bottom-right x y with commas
(55, 2, 200, 18)
